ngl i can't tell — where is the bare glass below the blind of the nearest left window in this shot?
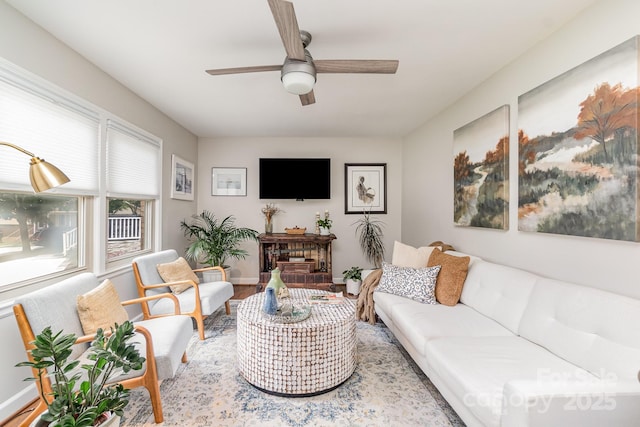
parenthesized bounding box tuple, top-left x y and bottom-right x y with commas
(0, 192, 84, 287)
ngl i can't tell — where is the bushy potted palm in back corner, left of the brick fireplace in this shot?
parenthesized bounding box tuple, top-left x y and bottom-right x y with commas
(180, 210, 258, 282)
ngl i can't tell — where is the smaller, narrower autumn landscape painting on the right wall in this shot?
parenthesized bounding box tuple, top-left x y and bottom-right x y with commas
(453, 105, 509, 230)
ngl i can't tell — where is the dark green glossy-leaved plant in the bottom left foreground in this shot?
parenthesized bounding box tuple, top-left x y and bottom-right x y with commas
(16, 321, 145, 427)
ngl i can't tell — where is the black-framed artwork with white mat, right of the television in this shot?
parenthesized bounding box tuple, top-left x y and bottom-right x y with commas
(344, 163, 387, 214)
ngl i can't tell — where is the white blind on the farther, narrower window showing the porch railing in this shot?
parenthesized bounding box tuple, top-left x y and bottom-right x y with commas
(107, 120, 161, 198)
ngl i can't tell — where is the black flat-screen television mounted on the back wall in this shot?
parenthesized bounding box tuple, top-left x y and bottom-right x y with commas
(260, 158, 331, 200)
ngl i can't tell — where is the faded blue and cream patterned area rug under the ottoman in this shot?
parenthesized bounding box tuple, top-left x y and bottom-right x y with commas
(121, 301, 464, 427)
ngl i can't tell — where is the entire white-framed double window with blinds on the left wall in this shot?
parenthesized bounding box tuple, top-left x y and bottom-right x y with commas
(0, 58, 162, 290)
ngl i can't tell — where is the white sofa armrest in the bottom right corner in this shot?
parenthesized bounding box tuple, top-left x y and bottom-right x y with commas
(501, 378, 640, 427)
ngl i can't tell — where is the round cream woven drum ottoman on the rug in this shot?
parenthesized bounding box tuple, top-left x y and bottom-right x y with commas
(238, 289, 356, 397)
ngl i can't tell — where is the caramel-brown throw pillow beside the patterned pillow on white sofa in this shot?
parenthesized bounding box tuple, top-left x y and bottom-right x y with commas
(427, 248, 470, 306)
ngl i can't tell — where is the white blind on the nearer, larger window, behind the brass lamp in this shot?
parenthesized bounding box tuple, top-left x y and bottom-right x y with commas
(0, 66, 100, 194)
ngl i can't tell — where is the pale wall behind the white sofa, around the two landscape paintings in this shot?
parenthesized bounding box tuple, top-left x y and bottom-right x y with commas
(402, 0, 640, 298)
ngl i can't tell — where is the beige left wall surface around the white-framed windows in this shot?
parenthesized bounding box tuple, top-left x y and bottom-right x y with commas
(0, 1, 198, 420)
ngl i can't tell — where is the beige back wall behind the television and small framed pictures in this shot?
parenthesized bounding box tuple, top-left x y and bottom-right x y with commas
(198, 138, 402, 283)
